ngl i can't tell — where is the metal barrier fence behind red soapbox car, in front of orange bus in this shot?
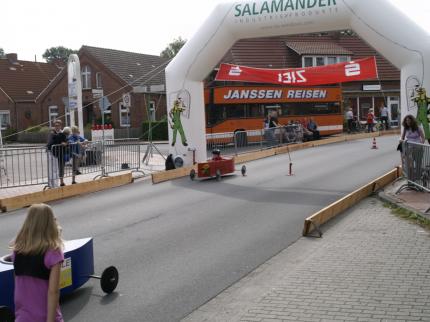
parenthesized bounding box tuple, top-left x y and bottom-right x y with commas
(206, 124, 306, 155)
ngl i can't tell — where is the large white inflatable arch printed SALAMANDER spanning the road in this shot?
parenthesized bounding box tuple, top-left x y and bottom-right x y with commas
(166, 0, 430, 164)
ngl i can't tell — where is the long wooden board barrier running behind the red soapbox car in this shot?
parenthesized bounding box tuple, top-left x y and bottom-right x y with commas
(152, 130, 400, 184)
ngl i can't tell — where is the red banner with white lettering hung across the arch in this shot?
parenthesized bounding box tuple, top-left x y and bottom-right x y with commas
(215, 57, 378, 86)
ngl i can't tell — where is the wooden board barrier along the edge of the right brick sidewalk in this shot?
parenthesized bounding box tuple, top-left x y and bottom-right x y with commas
(303, 167, 401, 236)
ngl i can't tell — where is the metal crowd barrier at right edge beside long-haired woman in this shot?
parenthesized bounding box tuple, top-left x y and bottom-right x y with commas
(397, 141, 430, 193)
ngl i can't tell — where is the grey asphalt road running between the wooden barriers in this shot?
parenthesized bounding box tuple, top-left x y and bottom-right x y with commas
(0, 137, 400, 322)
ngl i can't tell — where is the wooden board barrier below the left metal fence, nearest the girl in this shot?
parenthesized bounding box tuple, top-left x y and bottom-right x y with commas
(0, 173, 133, 212)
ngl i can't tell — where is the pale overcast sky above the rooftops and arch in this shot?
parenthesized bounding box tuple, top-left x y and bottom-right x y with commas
(0, 0, 430, 61)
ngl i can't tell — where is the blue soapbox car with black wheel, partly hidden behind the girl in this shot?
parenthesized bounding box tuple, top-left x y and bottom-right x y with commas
(0, 238, 119, 322)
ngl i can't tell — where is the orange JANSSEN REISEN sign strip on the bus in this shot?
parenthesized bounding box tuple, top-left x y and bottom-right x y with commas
(214, 86, 342, 104)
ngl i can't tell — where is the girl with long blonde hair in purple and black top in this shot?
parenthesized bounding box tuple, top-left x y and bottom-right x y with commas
(11, 204, 64, 322)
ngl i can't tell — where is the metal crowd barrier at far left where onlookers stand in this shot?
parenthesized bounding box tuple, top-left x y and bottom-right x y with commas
(0, 139, 141, 188)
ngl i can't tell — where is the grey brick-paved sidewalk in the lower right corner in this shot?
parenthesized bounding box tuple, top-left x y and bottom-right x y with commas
(183, 198, 430, 322)
